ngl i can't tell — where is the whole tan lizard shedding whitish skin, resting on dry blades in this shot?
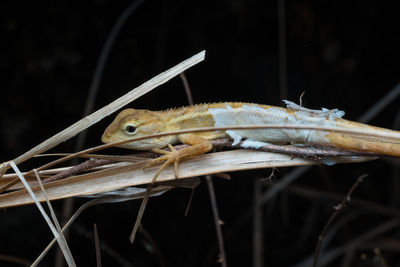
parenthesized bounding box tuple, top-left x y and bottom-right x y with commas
(101, 100, 400, 182)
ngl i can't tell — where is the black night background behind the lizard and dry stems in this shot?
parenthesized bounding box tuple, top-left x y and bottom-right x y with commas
(0, 0, 400, 266)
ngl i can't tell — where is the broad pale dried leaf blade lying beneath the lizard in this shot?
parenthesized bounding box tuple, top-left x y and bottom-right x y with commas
(0, 149, 371, 208)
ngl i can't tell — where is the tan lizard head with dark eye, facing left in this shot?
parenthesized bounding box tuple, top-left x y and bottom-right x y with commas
(101, 109, 174, 150)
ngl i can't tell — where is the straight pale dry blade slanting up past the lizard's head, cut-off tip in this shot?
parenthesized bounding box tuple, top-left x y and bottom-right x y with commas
(2, 51, 205, 172)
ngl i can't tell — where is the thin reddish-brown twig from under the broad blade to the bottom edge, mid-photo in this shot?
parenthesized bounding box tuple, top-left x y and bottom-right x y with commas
(206, 175, 227, 267)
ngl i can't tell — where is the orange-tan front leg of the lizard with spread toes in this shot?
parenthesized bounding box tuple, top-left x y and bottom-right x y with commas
(145, 133, 212, 183)
